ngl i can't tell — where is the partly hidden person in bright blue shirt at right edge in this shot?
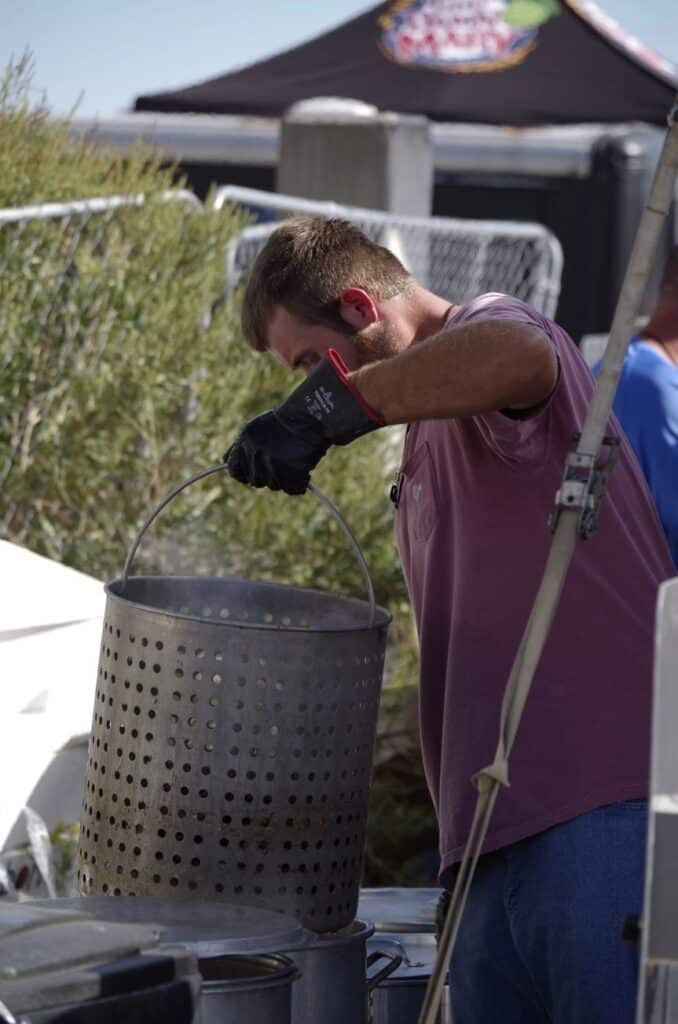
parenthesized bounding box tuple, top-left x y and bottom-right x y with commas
(593, 246, 678, 570)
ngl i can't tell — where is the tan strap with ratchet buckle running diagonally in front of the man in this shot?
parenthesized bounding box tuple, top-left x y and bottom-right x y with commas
(419, 94, 678, 1024)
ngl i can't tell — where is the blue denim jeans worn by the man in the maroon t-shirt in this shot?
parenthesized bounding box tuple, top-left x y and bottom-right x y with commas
(450, 800, 647, 1024)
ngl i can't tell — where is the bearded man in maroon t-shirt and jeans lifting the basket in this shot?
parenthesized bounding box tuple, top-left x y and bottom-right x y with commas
(225, 218, 671, 1024)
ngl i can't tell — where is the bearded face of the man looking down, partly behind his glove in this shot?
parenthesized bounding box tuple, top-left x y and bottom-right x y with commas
(267, 306, 397, 376)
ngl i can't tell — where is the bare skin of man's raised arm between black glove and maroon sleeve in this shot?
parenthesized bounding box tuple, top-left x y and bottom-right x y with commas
(349, 317, 558, 424)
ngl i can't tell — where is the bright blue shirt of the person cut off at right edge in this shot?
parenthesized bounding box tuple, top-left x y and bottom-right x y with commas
(593, 338, 678, 568)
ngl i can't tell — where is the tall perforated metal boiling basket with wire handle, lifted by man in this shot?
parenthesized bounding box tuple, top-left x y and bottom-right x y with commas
(78, 467, 390, 932)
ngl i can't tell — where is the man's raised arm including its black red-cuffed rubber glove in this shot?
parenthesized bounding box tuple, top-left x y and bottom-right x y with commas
(224, 318, 558, 495)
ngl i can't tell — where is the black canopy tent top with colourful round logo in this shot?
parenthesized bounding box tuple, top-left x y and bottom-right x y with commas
(135, 0, 675, 126)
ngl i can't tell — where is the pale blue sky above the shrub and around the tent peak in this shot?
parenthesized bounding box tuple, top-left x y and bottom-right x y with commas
(0, 0, 678, 115)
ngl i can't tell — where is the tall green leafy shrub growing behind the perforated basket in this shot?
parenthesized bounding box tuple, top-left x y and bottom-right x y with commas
(0, 58, 438, 883)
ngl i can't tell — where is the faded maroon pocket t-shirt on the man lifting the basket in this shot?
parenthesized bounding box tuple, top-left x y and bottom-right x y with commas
(395, 294, 673, 871)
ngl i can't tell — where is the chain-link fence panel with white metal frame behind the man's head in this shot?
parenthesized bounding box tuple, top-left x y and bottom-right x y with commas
(214, 185, 562, 316)
